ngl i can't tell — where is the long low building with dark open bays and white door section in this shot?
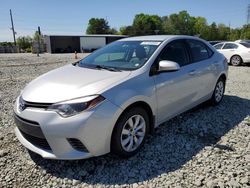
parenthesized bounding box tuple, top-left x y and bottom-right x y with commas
(45, 35, 127, 53)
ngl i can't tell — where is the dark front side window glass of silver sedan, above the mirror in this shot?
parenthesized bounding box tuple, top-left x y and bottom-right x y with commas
(158, 40, 189, 66)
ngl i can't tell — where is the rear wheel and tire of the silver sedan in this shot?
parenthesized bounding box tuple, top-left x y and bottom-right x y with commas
(210, 77, 226, 106)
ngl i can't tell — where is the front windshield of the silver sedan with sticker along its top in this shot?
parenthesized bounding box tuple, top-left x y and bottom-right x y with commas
(79, 41, 161, 70)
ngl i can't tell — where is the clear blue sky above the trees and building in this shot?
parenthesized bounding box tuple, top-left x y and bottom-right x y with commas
(0, 0, 250, 42)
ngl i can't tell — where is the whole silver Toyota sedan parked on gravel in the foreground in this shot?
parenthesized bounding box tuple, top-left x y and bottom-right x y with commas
(14, 36, 228, 160)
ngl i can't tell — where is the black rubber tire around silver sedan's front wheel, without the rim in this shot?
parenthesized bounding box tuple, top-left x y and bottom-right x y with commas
(111, 107, 149, 157)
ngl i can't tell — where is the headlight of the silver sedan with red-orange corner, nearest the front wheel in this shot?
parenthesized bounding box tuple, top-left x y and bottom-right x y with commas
(47, 95, 105, 117)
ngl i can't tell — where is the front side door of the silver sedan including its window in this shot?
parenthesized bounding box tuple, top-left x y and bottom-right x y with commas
(154, 40, 199, 123)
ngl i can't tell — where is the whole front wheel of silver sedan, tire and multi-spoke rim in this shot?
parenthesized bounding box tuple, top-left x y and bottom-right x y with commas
(111, 107, 149, 157)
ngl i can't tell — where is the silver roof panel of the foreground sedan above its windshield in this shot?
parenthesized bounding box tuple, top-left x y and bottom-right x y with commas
(121, 35, 197, 41)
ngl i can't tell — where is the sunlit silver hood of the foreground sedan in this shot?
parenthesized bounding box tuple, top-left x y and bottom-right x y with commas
(22, 65, 131, 103)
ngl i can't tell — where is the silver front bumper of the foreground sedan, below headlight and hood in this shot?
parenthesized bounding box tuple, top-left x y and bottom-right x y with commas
(14, 99, 121, 160)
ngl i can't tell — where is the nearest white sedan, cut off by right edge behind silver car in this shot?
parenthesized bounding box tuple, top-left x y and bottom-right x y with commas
(214, 42, 250, 66)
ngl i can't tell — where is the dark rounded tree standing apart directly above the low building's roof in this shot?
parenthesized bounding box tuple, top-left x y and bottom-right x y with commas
(86, 18, 110, 34)
